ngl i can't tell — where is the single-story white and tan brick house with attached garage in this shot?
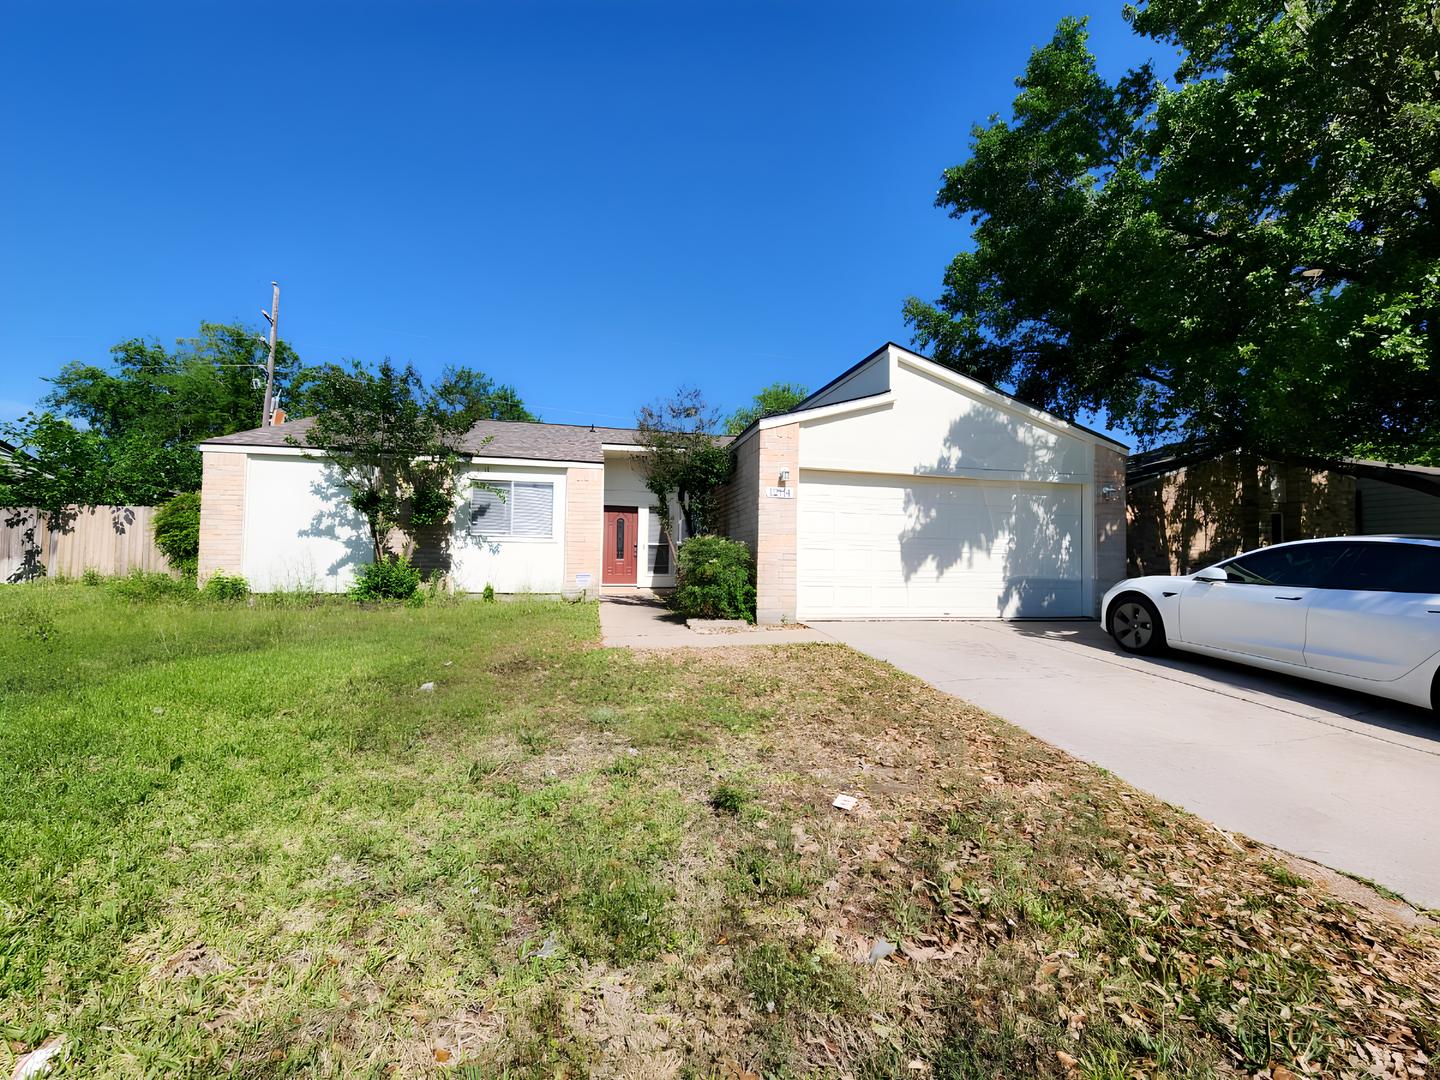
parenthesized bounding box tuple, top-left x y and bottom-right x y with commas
(200, 344, 1126, 622)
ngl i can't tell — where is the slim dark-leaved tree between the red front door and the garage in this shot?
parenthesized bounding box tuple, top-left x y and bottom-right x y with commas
(635, 387, 734, 546)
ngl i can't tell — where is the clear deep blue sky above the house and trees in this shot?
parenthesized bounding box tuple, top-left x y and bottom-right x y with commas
(0, 0, 1158, 434)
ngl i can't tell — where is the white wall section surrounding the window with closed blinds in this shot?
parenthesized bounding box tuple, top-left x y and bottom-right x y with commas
(451, 465, 566, 593)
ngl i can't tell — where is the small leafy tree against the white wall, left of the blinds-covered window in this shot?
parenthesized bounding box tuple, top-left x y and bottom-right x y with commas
(288, 360, 472, 563)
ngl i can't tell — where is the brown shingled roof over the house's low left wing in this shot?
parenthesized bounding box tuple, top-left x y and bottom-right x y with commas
(200, 416, 730, 464)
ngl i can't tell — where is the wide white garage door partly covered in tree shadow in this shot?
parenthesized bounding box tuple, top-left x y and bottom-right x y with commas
(796, 469, 1084, 619)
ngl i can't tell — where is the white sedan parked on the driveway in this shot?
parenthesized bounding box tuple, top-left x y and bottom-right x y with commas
(1100, 536, 1440, 713)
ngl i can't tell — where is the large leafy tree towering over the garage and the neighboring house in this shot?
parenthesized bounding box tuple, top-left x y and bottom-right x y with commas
(906, 0, 1440, 461)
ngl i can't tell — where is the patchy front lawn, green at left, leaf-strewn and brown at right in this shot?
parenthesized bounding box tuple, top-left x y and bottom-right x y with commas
(0, 583, 1440, 1080)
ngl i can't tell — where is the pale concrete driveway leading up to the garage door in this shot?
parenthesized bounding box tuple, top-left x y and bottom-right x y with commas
(812, 622, 1440, 907)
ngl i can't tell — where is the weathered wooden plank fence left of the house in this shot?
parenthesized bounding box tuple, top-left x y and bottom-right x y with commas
(0, 507, 173, 583)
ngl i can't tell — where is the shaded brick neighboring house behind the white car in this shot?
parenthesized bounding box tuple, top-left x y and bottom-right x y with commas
(1126, 446, 1440, 576)
